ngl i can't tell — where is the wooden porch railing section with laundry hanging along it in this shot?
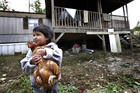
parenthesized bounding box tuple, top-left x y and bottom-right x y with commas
(52, 7, 129, 33)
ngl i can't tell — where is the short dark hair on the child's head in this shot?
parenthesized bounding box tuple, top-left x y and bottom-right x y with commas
(33, 25, 53, 43)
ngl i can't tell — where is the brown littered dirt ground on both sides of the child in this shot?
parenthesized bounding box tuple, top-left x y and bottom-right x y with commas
(0, 51, 140, 93)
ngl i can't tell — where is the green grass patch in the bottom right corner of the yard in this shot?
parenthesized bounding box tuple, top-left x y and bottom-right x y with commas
(86, 76, 140, 93)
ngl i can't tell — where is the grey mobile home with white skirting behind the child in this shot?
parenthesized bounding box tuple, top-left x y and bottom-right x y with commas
(0, 11, 49, 55)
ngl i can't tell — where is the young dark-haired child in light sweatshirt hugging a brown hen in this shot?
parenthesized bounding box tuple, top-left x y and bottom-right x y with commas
(20, 25, 62, 93)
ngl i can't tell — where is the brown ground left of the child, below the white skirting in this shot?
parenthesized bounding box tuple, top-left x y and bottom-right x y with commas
(0, 55, 25, 78)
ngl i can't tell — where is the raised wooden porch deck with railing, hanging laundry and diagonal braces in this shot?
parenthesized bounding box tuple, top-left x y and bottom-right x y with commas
(52, 6, 130, 52)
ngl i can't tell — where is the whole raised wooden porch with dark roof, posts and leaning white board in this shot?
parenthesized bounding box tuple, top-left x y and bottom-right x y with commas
(45, 0, 133, 53)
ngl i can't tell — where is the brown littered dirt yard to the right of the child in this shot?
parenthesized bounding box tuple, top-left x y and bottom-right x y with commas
(62, 51, 140, 93)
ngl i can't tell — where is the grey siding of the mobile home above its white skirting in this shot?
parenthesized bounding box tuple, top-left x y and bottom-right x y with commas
(0, 17, 50, 44)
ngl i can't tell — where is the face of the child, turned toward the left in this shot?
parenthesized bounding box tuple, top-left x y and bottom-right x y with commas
(33, 31, 49, 45)
